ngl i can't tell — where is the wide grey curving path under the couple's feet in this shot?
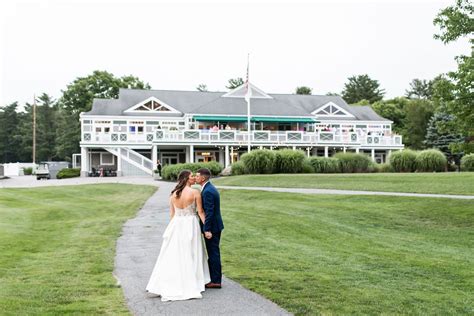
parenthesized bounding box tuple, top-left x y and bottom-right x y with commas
(114, 181, 290, 315)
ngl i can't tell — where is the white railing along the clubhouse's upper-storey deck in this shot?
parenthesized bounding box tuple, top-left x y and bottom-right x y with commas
(82, 130, 403, 147)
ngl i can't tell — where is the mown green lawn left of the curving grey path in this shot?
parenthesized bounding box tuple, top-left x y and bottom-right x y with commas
(0, 184, 155, 315)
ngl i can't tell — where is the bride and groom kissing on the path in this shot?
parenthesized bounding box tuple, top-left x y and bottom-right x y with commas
(146, 168, 224, 301)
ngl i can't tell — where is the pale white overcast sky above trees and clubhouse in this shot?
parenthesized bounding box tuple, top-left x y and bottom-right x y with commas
(0, 0, 469, 105)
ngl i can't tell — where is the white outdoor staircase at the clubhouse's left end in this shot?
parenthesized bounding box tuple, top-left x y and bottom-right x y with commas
(104, 147, 153, 176)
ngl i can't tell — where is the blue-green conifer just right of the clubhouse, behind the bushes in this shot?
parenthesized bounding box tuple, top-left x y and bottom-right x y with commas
(424, 112, 464, 159)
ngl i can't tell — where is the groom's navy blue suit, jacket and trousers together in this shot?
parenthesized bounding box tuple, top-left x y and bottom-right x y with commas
(201, 182, 224, 283)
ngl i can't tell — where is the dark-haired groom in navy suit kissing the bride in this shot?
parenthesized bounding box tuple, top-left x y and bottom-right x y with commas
(196, 168, 224, 289)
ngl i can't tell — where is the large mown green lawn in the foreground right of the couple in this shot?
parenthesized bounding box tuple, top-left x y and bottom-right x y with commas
(221, 189, 474, 315)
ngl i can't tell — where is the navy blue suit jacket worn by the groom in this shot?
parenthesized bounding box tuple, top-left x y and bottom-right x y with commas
(201, 182, 224, 233)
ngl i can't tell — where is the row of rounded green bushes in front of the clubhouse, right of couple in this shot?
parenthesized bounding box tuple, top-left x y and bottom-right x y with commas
(232, 149, 454, 175)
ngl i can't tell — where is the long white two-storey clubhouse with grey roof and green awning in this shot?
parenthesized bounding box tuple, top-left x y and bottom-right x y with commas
(75, 84, 404, 176)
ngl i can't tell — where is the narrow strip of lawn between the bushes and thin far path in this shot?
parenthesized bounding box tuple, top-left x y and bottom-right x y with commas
(213, 172, 474, 195)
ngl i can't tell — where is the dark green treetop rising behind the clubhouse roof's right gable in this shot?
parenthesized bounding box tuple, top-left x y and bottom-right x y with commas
(342, 75, 385, 104)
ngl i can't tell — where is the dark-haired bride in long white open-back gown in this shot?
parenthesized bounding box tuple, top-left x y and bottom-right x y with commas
(146, 170, 210, 301)
